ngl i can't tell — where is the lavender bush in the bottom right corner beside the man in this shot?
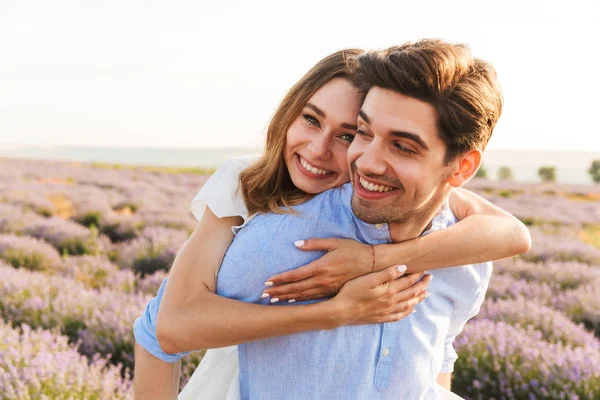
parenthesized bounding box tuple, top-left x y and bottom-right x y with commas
(453, 319, 600, 399)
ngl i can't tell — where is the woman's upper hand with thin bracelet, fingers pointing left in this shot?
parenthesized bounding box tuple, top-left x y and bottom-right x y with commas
(263, 239, 373, 301)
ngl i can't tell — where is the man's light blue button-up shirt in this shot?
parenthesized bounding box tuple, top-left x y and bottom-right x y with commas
(134, 184, 492, 400)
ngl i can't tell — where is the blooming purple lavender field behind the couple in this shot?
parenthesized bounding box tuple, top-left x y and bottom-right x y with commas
(0, 158, 600, 399)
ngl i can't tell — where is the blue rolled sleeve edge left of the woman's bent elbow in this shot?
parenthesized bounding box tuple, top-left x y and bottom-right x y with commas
(133, 278, 189, 363)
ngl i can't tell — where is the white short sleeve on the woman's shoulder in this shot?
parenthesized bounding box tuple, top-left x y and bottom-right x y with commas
(190, 156, 255, 222)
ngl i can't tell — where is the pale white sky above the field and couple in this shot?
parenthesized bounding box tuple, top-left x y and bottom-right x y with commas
(0, 0, 600, 152)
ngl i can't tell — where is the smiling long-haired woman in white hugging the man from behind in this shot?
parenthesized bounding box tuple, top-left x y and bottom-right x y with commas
(136, 50, 529, 398)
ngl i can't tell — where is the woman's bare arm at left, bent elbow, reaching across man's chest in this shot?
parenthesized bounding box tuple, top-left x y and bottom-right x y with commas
(156, 208, 429, 353)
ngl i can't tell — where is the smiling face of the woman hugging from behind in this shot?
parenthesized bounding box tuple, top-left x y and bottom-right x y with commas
(284, 78, 361, 194)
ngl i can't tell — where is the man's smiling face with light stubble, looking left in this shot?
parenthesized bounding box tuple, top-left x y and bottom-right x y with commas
(348, 87, 454, 224)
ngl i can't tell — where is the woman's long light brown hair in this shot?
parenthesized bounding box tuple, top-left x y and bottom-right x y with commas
(239, 49, 363, 215)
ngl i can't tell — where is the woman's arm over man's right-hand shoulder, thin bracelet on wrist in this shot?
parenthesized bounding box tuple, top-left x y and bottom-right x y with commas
(264, 188, 531, 300)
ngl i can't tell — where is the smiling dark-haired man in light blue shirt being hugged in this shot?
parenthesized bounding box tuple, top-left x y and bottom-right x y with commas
(200, 40, 502, 400)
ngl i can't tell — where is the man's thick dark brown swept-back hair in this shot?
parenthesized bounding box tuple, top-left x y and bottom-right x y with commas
(355, 39, 502, 164)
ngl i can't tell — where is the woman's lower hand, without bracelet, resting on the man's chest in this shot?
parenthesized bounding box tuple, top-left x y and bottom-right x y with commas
(329, 265, 431, 325)
